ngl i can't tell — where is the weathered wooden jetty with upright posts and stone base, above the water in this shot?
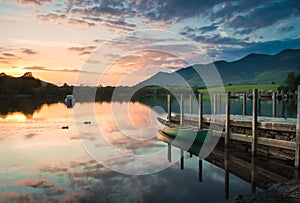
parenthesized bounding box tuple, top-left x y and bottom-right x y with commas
(167, 85, 300, 169)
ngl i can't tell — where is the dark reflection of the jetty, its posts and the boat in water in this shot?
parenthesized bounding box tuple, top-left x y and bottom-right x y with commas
(157, 132, 300, 199)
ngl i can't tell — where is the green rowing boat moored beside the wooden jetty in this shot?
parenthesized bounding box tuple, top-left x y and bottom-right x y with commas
(157, 118, 211, 143)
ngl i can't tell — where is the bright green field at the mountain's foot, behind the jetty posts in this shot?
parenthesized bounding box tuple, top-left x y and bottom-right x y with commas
(199, 84, 280, 93)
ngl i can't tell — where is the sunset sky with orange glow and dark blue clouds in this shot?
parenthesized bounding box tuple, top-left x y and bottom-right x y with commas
(0, 0, 300, 86)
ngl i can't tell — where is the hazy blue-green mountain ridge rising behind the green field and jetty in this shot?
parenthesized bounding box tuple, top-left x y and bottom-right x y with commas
(137, 49, 300, 86)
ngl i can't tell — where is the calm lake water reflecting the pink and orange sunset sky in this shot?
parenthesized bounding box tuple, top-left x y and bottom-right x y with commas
(0, 98, 294, 202)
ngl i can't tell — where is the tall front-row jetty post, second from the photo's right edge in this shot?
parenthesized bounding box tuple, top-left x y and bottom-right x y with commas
(251, 89, 258, 156)
